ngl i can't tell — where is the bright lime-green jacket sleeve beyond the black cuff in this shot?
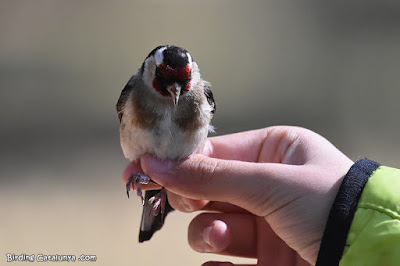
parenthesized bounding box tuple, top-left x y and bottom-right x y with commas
(339, 166, 400, 266)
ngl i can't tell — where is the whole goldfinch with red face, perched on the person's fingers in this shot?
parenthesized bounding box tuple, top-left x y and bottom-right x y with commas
(117, 45, 216, 242)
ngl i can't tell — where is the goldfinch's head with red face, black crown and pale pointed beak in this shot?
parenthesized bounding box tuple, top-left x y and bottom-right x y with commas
(141, 45, 200, 107)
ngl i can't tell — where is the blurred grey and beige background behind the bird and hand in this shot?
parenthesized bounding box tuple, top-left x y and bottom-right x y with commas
(0, 0, 400, 265)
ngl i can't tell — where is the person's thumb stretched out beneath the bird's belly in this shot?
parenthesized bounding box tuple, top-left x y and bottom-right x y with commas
(141, 154, 289, 211)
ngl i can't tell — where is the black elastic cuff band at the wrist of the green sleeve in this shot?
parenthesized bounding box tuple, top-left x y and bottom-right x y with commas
(316, 159, 380, 266)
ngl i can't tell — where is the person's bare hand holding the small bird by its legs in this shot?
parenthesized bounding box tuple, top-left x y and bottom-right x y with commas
(124, 126, 353, 265)
